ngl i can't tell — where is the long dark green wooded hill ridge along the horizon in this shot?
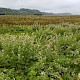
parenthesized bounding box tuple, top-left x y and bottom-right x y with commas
(0, 8, 72, 16)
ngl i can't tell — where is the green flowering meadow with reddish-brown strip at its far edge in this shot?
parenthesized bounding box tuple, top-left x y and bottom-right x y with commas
(0, 16, 80, 80)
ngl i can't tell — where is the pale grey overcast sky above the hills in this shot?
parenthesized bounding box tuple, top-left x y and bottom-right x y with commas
(0, 0, 80, 14)
